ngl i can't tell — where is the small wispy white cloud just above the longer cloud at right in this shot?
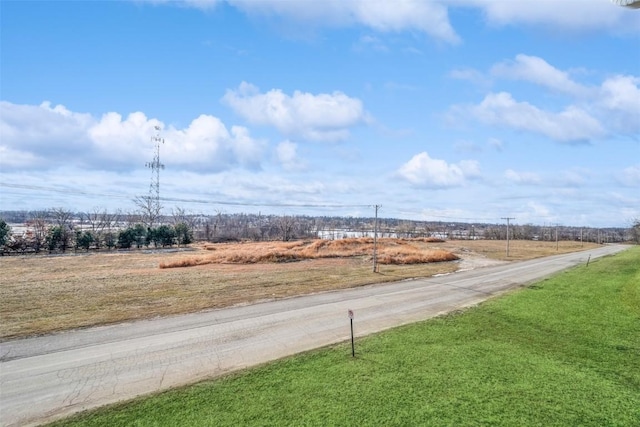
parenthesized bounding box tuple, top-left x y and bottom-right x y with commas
(491, 54, 588, 96)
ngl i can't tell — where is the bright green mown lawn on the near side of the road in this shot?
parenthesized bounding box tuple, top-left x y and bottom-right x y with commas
(50, 247, 640, 427)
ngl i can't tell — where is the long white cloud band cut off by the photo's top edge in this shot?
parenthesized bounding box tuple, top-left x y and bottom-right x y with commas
(144, 0, 640, 44)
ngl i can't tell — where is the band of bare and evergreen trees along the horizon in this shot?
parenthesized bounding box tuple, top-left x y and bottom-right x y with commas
(0, 208, 640, 253)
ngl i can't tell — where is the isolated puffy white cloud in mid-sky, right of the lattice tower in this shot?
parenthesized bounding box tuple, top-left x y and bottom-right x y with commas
(223, 82, 368, 141)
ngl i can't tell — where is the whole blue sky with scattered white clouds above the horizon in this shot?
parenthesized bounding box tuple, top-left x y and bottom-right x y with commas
(0, 0, 640, 227)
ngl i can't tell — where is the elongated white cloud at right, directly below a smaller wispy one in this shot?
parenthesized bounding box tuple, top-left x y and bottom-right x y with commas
(452, 92, 605, 142)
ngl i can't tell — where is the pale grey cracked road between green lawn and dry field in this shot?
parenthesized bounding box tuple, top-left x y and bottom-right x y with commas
(0, 245, 625, 426)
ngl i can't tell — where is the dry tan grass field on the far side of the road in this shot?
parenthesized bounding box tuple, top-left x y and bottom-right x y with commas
(0, 239, 595, 341)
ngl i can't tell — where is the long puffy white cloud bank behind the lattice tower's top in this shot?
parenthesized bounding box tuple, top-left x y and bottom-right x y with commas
(0, 102, 265, 171)
